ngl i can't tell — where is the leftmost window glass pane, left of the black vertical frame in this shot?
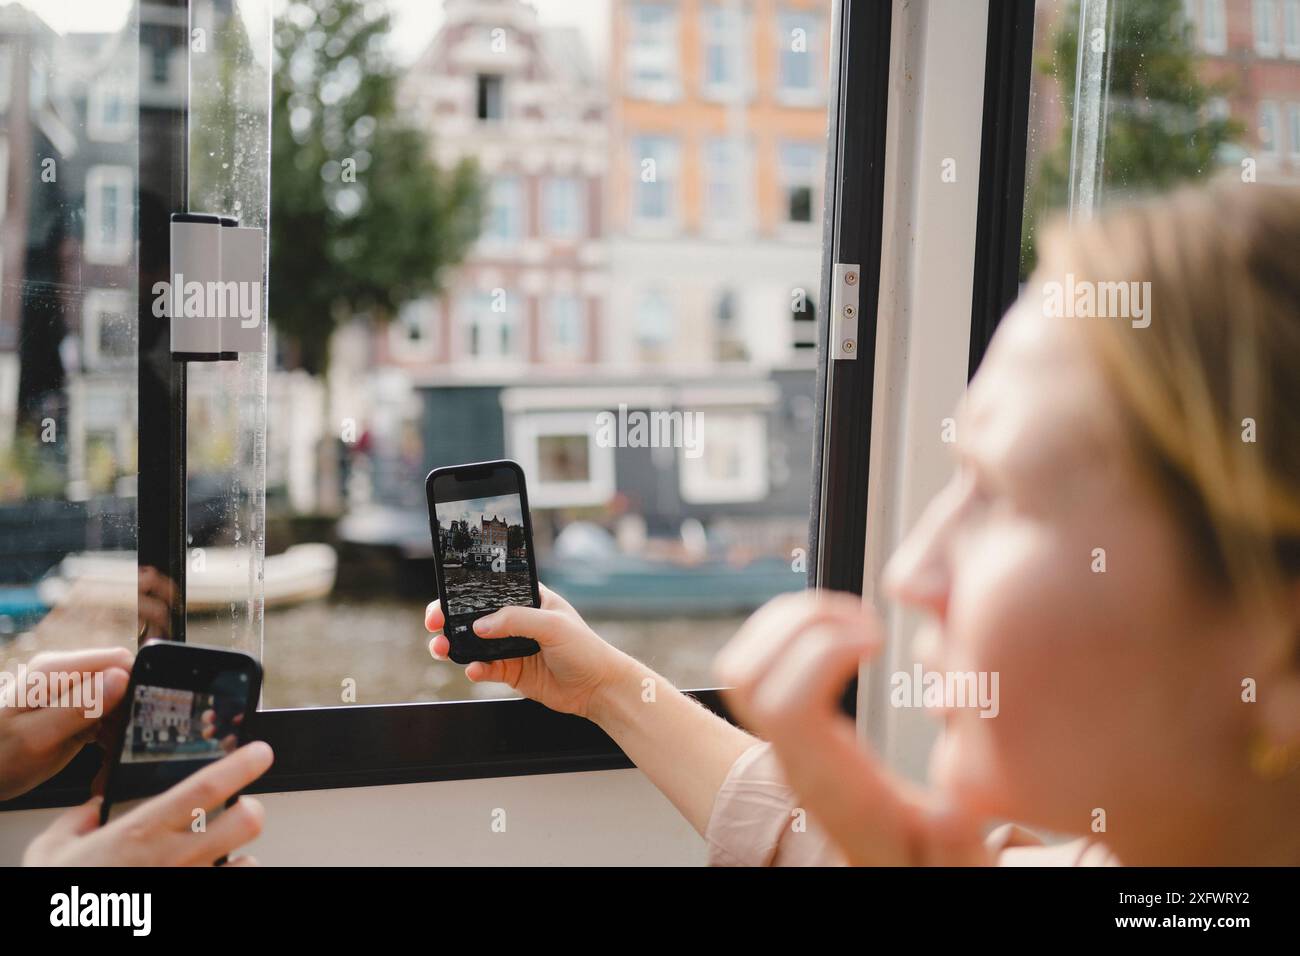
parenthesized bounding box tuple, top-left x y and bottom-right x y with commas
(0, 0, 141, 674)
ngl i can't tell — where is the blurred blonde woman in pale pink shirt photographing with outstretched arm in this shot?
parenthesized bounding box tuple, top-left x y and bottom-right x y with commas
(426, 185, 1300, 865)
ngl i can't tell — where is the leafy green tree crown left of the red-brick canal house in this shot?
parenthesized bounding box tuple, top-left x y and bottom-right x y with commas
(270, 0, 482, 372)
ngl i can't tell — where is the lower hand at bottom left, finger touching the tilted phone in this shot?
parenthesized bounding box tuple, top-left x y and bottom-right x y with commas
(22, 741, 273, 866)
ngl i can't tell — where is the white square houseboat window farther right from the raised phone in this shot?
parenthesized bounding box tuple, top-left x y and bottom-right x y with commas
(677, 410, 768, 505)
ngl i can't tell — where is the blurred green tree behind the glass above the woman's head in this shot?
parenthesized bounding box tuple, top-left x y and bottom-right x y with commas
(1021, 0, 1243, 278)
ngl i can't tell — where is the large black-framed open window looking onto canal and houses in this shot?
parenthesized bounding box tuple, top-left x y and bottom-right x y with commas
(0, 0, 892, 805)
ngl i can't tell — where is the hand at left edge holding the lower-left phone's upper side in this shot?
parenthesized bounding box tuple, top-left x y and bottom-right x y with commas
(0, 648, 133, 800)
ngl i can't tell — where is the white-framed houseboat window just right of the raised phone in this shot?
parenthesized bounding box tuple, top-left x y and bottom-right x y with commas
(511, 412, 615, 507)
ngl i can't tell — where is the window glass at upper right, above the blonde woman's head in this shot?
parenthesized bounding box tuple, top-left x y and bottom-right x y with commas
(1021, 0, 1300, 277)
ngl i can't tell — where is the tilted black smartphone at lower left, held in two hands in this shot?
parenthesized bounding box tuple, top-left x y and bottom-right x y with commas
(100, 641, 261, 825)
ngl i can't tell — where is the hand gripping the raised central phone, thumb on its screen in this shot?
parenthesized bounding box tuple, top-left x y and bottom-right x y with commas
(424, 587, 636, 718)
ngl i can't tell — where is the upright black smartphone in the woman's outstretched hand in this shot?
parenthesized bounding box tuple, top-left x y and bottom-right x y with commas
(424, 460, 542, 663)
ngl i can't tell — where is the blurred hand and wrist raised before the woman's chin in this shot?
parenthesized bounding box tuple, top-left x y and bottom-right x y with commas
(714, 591, 991, 866)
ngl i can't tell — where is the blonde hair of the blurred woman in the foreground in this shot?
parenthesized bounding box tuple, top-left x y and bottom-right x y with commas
(1043, 181, 1300, 639)
